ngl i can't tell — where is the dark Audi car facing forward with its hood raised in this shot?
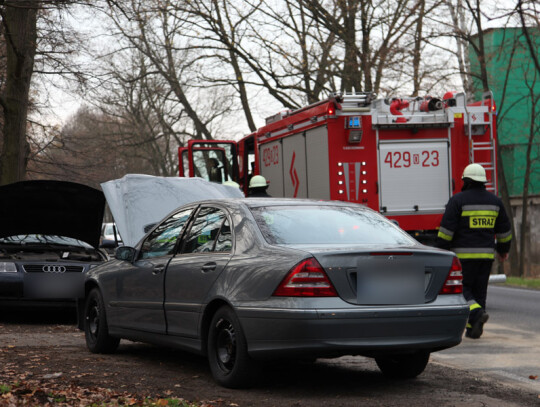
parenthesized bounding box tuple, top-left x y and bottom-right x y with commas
(0, 181, 107, 306)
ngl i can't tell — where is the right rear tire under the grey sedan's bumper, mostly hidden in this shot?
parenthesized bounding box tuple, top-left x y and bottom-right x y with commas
(375, 352, 429, 379)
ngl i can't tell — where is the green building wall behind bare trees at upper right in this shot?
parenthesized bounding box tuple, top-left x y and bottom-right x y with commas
(469, 28, 540, 196)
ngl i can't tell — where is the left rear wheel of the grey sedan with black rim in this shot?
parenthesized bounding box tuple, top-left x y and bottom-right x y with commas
(207, 306, 257, 388)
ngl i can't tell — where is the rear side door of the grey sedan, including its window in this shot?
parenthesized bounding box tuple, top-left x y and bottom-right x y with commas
(165, 206, 233, 338)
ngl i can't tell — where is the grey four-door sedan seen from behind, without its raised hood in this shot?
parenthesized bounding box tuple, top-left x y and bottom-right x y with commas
(79, 198, 468, 387)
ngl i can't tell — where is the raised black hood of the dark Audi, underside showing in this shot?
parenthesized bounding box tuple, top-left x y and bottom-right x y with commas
(0, 181, 105, 248)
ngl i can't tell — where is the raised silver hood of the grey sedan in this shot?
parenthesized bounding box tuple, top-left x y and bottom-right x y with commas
(101, 174, 244, 246)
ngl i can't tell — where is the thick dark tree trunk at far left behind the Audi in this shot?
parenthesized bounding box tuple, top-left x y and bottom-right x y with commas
(0, 0, 39, 185)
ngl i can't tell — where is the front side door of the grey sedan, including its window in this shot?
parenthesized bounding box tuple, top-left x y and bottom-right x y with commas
(111, 208, 193, 334)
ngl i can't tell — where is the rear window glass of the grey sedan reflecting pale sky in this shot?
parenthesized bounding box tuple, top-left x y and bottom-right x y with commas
(251, 206, 415, 245)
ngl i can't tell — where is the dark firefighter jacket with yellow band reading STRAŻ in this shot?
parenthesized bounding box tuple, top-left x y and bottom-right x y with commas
(437, 183, 512, 260)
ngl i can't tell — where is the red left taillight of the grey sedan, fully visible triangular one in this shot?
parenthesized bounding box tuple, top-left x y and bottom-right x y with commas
(274, 257, 337, 297)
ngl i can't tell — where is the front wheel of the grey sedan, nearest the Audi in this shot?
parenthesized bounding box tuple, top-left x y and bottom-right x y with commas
(84, 288, 120, 353)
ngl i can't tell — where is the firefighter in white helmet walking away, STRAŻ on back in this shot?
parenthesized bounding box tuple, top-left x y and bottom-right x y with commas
(437, 164, 512, 339)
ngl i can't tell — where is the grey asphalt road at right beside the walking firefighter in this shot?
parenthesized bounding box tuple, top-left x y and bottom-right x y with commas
(432, 286, 540, 394)
